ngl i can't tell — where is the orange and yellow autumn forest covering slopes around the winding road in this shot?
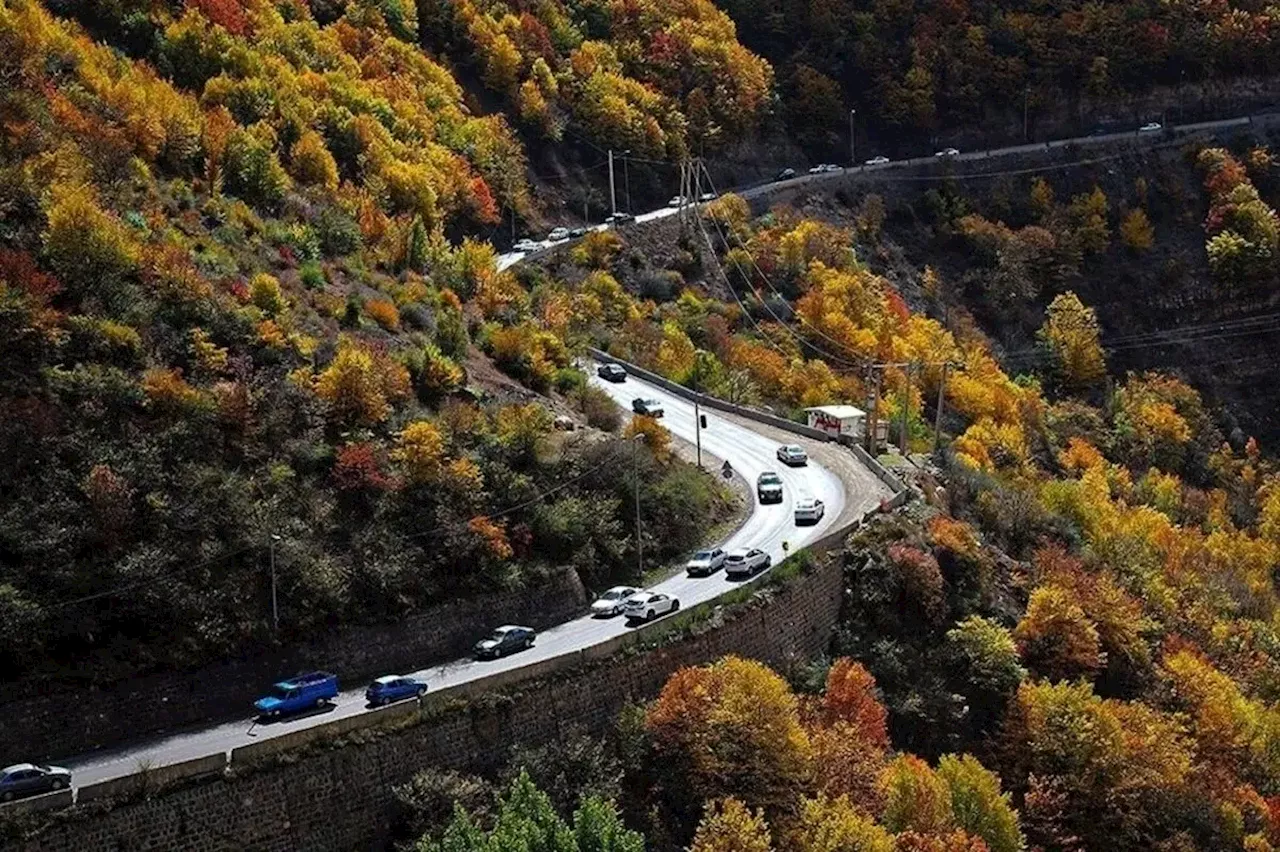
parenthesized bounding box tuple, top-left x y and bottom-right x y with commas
(0, 0, 1280, 852)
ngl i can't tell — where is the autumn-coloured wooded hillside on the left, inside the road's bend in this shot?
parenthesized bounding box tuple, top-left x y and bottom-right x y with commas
(0, 0, 726, 679)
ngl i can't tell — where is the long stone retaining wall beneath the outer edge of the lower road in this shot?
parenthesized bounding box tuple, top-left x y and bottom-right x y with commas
(13, 547, 842, 852)
